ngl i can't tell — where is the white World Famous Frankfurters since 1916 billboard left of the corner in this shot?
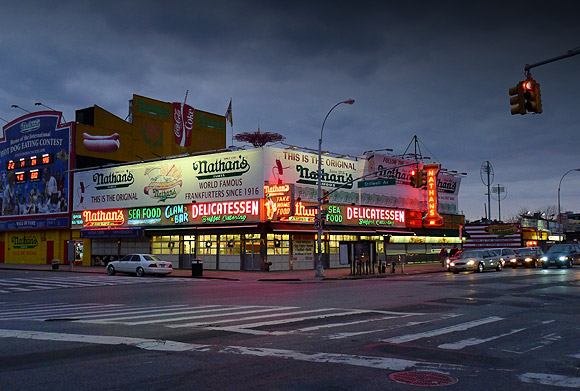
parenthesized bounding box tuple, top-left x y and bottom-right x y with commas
(73, 149, 264, 211)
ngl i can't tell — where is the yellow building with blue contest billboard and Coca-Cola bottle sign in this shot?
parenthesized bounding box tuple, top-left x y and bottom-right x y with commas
(0, 95, 226, 265)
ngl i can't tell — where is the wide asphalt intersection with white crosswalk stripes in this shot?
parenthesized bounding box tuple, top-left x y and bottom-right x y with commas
(0, 266, 580, 391)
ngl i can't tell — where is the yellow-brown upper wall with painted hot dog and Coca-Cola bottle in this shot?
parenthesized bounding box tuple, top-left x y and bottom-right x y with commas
(76, 95, 226, 162)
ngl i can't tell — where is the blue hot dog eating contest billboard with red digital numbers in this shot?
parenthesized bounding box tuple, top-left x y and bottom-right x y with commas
(0, 111, 74, 229)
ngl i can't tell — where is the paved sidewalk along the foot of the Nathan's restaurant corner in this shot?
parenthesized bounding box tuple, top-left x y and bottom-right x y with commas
(0, 263, 446, 281)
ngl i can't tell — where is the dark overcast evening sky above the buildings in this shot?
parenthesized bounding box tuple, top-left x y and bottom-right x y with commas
(0, 0, 580, 220)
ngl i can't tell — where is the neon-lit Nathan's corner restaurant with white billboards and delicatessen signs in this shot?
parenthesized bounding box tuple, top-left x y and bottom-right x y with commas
(71, 147, 461, 270)
